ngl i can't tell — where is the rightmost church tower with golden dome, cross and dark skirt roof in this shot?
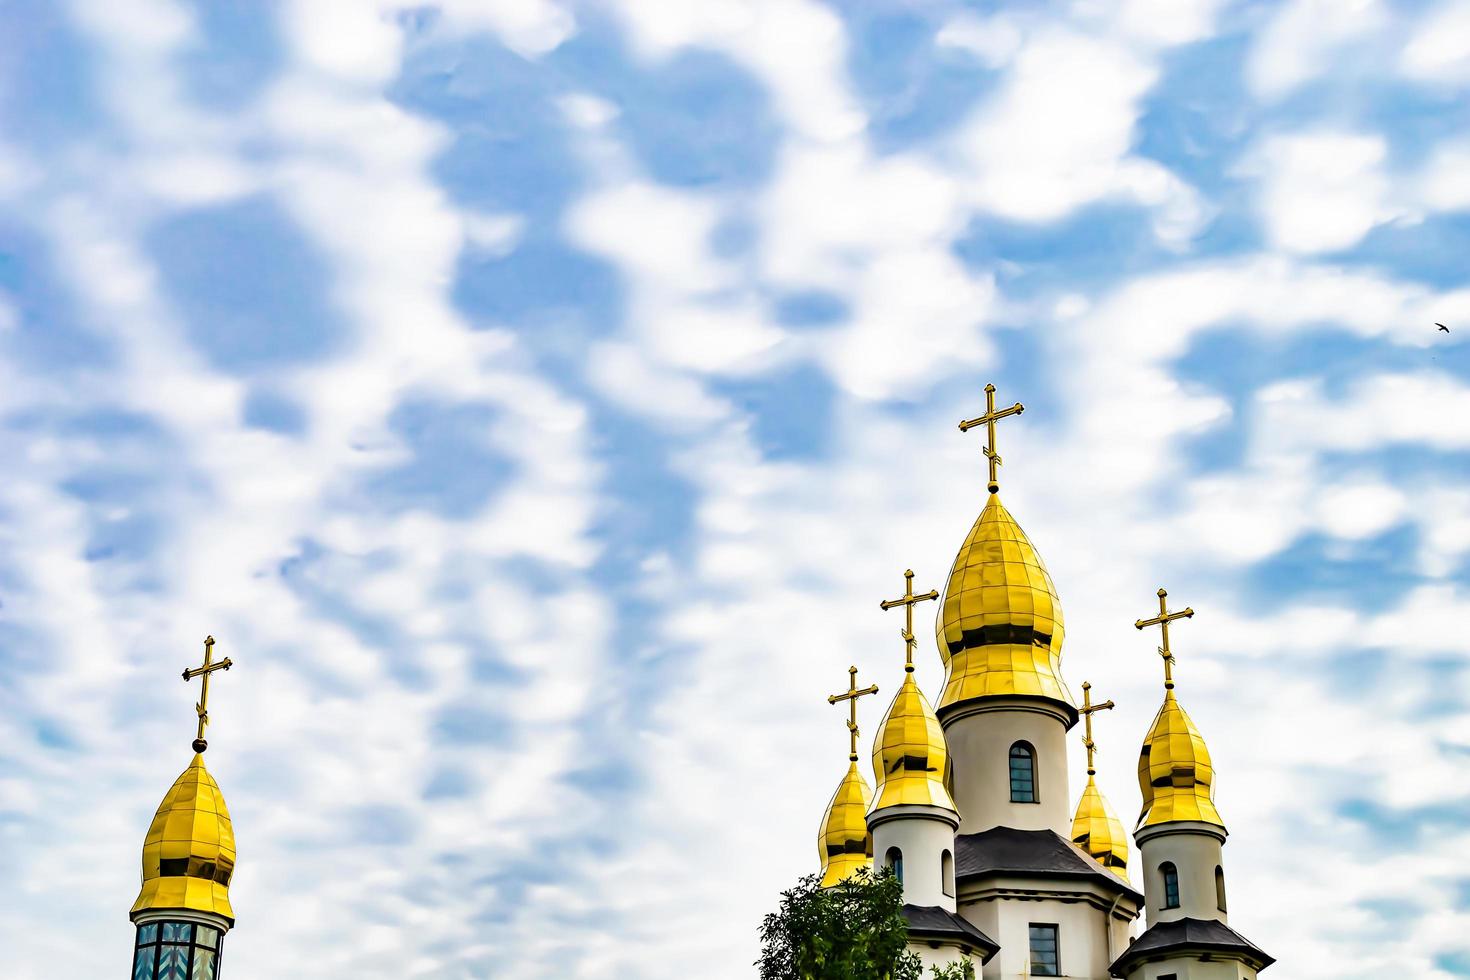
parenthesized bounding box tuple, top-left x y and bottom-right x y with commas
(1113, 589, 1274, 980)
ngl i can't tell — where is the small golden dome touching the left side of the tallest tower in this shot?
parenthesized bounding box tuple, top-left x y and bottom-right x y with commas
(873, 667, 954, 811)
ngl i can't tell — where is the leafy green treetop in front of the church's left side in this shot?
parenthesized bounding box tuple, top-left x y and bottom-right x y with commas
(756, 868, 922, 980)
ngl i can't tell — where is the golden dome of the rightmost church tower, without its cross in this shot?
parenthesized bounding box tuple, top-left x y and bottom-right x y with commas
(1138, 689, 1225, 827)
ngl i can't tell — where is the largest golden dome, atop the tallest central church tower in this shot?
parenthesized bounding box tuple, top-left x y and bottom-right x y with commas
(935, 494, 1072, 708)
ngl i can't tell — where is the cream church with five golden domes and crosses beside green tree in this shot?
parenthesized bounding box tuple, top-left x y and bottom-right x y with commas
(817, 385, 1273, 980)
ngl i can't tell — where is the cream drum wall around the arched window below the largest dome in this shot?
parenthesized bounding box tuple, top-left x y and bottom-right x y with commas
(944, 698, 1072, 836)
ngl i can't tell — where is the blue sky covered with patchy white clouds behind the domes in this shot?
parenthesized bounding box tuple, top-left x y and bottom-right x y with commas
(0, 0, 1470, 980)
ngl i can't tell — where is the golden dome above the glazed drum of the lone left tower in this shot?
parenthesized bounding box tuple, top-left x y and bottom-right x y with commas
(132, 754, 235, 926)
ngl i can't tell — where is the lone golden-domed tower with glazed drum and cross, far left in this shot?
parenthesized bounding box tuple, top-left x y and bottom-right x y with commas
(131, 636, 235, 980)
